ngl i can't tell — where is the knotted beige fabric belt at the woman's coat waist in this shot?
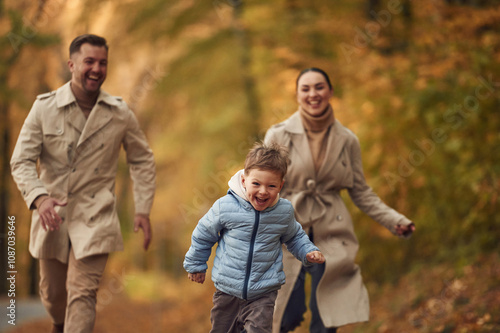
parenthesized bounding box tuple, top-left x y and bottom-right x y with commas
(287, 179, 340, 226)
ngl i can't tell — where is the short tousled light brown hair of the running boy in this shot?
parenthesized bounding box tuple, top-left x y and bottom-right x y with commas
(245, 142, 290, 179)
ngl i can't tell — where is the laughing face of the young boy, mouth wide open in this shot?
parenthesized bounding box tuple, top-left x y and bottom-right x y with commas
(241, 169, 285, 211)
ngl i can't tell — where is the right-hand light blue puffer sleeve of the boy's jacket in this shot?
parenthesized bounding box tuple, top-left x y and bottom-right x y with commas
(281, 214, 319, 266)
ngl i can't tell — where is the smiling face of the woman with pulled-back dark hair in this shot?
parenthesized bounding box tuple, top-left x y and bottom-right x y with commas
(297, 71, 333, 116)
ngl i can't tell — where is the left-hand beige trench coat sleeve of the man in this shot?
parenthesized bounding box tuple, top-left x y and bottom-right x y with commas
(10, 100, 48, 209)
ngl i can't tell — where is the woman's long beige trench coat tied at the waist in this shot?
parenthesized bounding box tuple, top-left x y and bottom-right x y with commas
(265, 112, 411, 332)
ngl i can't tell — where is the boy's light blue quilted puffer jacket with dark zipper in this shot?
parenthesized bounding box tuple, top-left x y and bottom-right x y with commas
(184, 189, 318, 300)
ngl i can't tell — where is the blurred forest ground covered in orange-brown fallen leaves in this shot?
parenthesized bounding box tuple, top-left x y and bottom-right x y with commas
(1, 254, 500, 333)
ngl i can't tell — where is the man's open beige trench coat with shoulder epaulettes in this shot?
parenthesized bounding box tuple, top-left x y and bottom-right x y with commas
(11, 82, 155, 263)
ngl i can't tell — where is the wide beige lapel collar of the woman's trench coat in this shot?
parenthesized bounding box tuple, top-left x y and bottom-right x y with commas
(285, 111, 349, 180)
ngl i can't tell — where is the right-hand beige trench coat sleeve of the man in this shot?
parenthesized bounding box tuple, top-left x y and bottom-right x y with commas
(123, 109, 156, 215)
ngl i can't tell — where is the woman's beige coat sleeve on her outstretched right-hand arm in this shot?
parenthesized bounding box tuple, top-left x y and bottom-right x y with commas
(349, 136, 411, 234)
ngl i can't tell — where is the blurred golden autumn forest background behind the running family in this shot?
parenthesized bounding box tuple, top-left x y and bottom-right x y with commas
(0, 0, 500, 333)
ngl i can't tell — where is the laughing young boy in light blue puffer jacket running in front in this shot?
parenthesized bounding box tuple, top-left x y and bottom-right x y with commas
(184, 144, 325, 333)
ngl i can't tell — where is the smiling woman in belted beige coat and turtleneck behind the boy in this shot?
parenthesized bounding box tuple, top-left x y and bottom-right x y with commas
(265, 68, 415, 333)
